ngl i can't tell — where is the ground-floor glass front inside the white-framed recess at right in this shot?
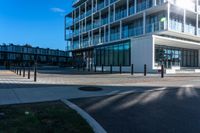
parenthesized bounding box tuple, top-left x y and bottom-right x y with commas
(155, 45, 199, 68)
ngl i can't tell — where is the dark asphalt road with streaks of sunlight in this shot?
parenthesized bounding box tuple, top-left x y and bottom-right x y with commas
(71, 87, 200, 133)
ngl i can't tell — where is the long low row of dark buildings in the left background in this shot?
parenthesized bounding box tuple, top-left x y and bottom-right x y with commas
(0, 44, 68, 66)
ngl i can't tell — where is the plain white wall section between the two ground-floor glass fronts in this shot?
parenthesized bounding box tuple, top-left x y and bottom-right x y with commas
(131, 35, 154, 72)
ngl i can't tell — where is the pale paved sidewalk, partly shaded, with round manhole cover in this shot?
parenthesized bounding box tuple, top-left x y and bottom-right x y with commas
(0, 71, 200, 105)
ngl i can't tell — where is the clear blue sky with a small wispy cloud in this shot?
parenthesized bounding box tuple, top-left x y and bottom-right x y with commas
(0, 0, 72, 50)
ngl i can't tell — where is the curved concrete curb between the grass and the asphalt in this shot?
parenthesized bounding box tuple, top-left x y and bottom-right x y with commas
(61, 99, 107, 133)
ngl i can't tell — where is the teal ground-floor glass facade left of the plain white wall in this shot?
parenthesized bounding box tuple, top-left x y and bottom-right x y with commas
(95, 41, 131, 66)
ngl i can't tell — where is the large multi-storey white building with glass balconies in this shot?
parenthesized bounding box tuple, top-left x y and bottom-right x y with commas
(65, 0, 200, 73)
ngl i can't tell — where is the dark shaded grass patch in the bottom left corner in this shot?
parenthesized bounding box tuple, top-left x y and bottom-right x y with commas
(0, 101, 93, 133)
